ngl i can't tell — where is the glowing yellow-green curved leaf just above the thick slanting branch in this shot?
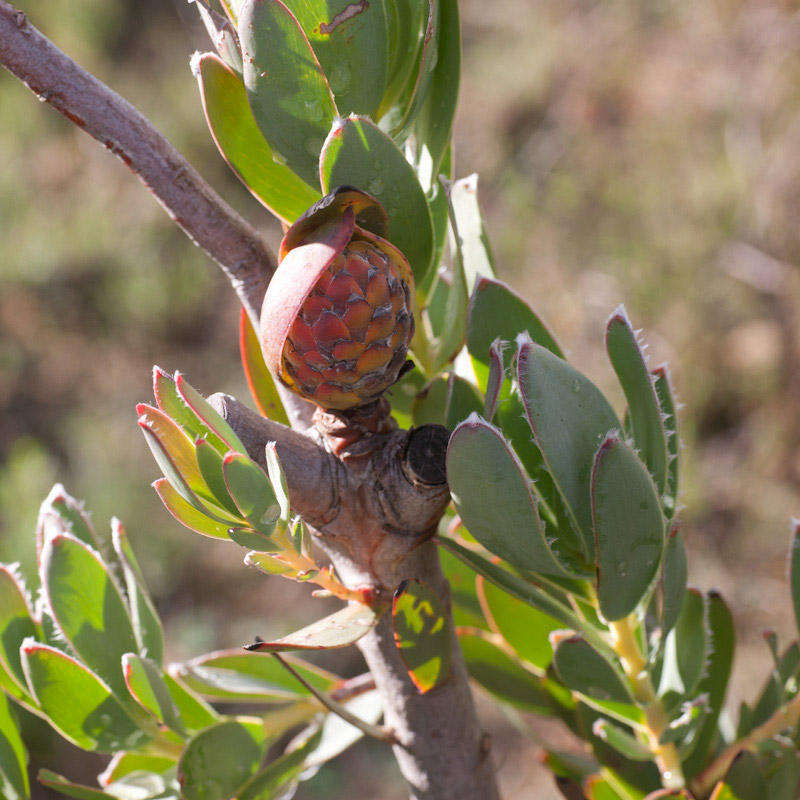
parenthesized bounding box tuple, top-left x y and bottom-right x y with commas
(192, 53, 321, 223)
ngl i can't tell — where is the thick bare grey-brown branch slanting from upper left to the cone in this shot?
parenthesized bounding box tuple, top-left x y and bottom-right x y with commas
(0, 0, 275, 326)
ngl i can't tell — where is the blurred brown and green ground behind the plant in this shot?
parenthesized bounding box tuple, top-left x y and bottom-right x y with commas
(0, 0, 800, 800)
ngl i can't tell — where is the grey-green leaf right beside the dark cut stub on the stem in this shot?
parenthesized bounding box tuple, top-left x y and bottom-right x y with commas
(447, 414, 563, 574)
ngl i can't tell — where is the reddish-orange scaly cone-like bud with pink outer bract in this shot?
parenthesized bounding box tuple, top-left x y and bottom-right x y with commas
(261, 187, 414, 410)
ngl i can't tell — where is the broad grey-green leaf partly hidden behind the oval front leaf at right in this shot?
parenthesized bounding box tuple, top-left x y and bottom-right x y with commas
(516, 340, 620, 564)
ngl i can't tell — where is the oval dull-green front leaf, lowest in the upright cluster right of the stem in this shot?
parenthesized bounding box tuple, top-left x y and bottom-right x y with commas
(591, 435, 664, 620)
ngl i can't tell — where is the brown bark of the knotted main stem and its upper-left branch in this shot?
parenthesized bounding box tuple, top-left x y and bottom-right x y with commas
(0, 7, 498, 800)
